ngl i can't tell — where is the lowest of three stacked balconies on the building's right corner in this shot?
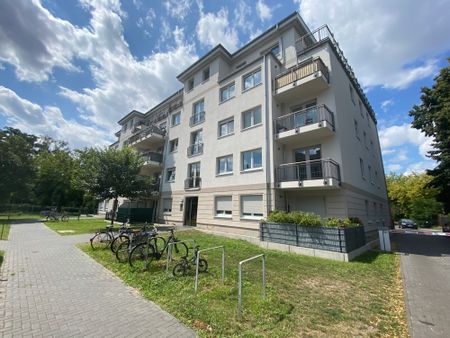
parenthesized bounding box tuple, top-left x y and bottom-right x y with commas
(275, 159, 341, 190)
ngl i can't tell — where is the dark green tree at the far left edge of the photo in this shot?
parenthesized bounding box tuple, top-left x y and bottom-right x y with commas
(0, 127, 40, 202)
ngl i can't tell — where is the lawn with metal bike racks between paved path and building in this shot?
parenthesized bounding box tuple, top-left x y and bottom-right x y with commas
(80, 231, 407, 337)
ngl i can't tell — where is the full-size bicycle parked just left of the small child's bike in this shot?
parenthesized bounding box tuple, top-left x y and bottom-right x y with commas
(128, 229, 189, 271)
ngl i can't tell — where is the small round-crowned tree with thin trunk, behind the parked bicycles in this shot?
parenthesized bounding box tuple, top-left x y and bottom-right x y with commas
(77, 148, 152, 224)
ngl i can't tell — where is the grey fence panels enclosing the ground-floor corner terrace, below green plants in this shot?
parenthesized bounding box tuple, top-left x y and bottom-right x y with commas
(260, 222, 366, 253)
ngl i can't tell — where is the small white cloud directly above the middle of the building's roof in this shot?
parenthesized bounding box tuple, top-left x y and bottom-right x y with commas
(197, 8, 239, 52)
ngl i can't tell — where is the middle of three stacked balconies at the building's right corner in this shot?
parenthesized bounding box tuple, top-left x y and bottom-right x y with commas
(274, 105, 335, 144)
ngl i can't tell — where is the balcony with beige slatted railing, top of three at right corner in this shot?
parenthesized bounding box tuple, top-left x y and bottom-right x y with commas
(274, 58, 330, 100)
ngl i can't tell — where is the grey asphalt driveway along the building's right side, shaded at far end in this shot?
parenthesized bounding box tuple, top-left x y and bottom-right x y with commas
(392, 234, 450, 338)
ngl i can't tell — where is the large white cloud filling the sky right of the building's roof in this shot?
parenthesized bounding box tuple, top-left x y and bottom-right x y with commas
(295, 0, 450, 88)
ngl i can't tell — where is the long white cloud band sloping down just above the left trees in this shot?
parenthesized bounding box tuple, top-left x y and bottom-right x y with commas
(0, 86, 112, 148)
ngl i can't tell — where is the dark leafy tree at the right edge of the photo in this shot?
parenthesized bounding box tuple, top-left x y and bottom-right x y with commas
(409, 58, 450, 212)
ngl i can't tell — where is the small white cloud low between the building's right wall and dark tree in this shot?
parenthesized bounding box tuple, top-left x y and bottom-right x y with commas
(378, 123, 433, 159)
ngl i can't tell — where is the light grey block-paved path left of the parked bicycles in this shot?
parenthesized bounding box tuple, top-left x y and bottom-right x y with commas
(0, 223, 195, 337)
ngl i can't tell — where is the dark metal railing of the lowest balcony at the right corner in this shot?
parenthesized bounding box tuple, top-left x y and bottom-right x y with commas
(276, 159, 341, 182)
